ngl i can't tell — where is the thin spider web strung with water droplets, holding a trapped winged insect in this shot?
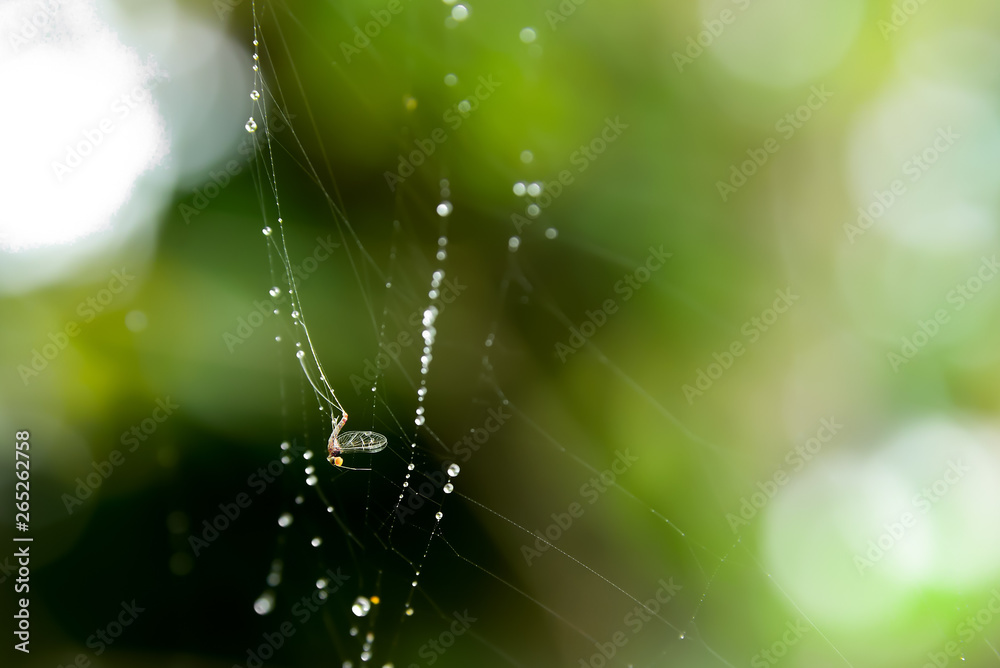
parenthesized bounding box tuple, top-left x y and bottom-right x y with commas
(227, 2, 850, 666)
